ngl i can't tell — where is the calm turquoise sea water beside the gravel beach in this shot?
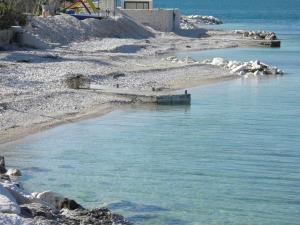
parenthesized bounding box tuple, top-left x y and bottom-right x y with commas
(0, 0, 300, 225)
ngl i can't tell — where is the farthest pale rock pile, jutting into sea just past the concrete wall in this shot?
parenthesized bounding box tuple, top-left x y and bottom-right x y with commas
(180, 15, 223, 30)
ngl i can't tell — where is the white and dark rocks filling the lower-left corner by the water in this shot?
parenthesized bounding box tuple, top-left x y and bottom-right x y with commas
(0, 156, 131, 225)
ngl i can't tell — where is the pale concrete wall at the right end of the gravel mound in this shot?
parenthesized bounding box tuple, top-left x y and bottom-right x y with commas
(121, 9, 181, 32)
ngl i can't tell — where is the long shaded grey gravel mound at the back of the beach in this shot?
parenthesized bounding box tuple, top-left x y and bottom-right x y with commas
(26, 14, 154, 45)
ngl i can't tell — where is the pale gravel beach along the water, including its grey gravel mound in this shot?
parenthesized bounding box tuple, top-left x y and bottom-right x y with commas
(0, 16, 278, 143)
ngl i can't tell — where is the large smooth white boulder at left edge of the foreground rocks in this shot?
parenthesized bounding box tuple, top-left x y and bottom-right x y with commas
(0, 184, 20, 214)
